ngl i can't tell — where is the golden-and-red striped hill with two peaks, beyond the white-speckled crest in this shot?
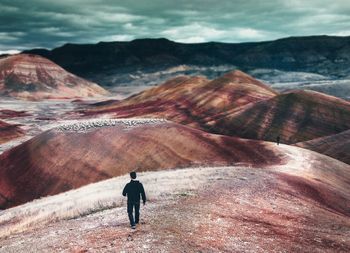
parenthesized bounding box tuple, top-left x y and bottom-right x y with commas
(80, 70, 277, 130)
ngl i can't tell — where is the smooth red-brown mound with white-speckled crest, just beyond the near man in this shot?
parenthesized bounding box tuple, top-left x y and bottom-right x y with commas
(0, 119, 280, 209)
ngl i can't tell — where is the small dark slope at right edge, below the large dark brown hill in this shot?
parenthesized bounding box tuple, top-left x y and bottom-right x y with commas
(295, 130, 350, 164)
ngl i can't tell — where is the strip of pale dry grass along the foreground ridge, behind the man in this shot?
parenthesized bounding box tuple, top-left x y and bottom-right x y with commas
(0, 167, 230, 237)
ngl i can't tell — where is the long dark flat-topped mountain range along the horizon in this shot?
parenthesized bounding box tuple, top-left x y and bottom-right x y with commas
(26, 36, 350, 86)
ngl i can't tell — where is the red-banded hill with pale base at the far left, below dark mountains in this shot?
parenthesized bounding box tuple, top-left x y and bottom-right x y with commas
(0, 54, 107, 100)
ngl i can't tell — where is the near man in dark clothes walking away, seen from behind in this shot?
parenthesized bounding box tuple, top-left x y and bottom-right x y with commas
(123, 171, 146, 229)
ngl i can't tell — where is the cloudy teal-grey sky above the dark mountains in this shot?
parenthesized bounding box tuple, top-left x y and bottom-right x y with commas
(0, 0, 350, 54)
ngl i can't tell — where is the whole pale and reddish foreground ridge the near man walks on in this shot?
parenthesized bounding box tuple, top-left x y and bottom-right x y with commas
(0, 145, 350, 252)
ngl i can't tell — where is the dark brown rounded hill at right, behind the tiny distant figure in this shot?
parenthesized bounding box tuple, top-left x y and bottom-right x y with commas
(214, 91, 350, 144)
